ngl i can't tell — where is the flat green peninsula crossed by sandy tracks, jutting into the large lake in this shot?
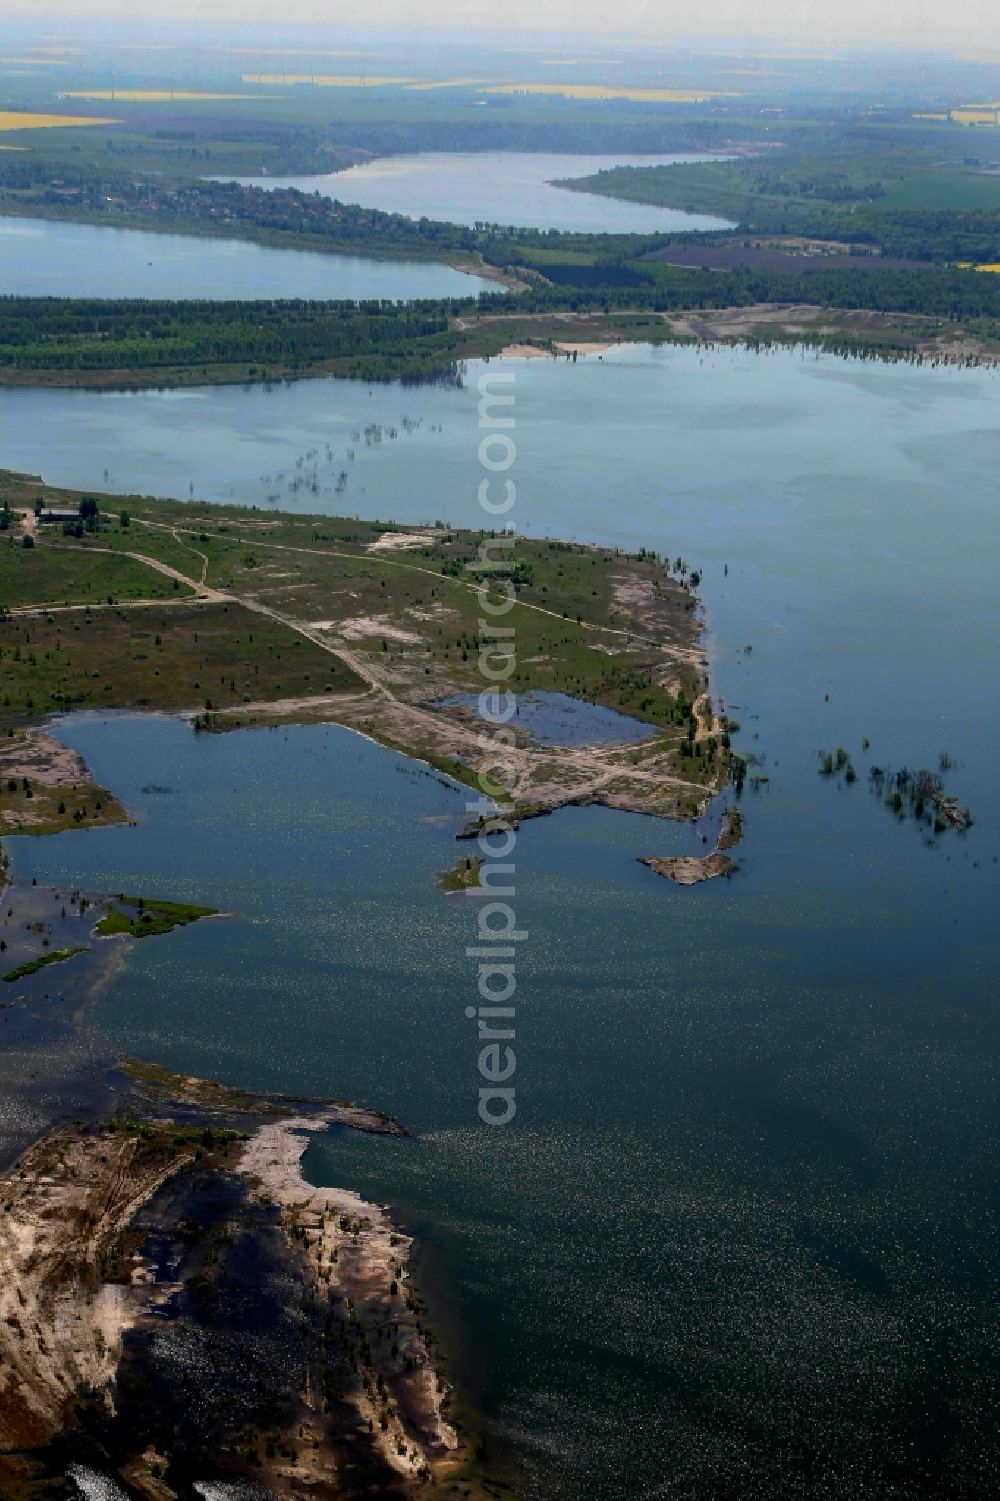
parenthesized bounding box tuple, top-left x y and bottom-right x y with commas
(0, 473, 730, 832)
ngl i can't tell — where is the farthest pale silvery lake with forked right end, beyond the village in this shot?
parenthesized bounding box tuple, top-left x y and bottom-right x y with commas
(231, 152, 731, 234)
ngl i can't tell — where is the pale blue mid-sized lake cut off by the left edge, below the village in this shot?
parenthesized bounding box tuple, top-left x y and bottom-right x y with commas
(0, 215, 497, 302)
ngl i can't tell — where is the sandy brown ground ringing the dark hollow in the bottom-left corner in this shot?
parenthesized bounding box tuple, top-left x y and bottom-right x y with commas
(0, 1092, 467, 1498)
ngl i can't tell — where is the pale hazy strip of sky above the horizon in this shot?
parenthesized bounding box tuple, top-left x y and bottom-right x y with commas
(7, 0, 1000, 50)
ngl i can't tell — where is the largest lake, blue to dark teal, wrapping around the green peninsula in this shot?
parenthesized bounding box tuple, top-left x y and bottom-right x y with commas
(7, 348, 1000, 1501)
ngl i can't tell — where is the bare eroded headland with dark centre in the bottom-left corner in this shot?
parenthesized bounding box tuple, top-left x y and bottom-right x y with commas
(0, 1079, 467, 1501)
